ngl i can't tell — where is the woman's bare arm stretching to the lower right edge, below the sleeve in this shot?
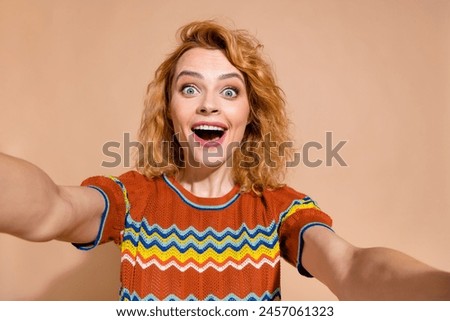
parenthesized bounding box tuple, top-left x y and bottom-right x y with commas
(302, 226, 450, 301)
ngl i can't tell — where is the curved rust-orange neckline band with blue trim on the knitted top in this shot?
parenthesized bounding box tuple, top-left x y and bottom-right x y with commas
(163, 175, 241, 210)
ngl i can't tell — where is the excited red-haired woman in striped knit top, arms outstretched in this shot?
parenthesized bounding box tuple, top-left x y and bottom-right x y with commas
(0, 21, 450, 300)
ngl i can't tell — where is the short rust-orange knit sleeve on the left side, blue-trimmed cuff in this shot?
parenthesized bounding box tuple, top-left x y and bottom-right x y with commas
(74, 172, 130, 250)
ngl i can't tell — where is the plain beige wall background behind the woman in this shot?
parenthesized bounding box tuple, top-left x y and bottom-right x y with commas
(0, 0, 450, 300)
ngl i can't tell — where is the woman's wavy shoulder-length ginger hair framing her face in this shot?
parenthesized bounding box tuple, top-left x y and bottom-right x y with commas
(137, 20, 292, 195)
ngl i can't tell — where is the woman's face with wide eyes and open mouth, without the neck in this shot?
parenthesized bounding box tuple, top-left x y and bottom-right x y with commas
(170, 48, 250, 168)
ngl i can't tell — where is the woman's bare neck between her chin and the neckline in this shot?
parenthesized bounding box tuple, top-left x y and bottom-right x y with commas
(177, 166, 235, 198)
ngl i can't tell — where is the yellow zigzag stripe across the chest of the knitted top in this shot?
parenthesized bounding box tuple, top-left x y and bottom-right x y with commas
(122, 241, 280, 264)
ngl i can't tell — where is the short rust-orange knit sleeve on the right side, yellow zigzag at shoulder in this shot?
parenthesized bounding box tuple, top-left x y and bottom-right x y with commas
(279, 195, 332, 277)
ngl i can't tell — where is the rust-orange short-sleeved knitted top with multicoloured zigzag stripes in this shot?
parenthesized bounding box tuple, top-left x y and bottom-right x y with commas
(76, 171, 331, 300)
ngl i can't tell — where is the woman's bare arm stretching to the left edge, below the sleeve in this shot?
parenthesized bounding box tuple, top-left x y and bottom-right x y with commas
(0, 153, 105, 243)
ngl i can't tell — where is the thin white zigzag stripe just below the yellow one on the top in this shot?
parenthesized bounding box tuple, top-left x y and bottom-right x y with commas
(121, 254, 280, 273)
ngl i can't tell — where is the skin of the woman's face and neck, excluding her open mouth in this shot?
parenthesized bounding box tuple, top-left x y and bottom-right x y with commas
(170, 48, 250, 197)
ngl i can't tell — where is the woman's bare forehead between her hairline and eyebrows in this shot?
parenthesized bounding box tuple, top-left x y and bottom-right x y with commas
(175, 48, 242, 76)
